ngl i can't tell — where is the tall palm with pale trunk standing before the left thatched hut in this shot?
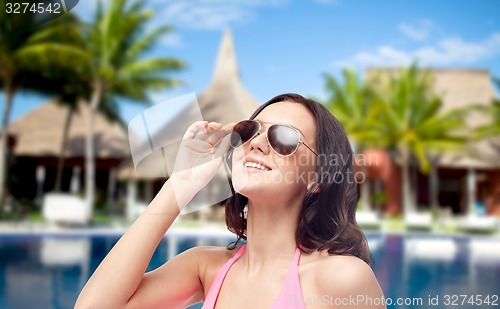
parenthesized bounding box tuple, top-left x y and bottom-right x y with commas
(84, 0, 185, 205)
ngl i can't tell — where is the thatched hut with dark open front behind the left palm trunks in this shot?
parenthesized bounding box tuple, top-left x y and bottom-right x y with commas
(9, 101, 130, 207)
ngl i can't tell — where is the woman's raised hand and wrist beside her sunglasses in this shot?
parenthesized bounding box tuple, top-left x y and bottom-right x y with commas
(170, 121, 234, 210)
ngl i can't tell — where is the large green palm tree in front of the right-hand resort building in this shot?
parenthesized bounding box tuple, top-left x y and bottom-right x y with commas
(377, 64, 467, 213)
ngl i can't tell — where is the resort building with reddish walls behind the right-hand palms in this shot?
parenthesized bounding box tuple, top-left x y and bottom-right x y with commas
(365, 68, 500, 215)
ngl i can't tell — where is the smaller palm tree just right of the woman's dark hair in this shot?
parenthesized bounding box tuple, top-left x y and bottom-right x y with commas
(323, 69, 378, 210)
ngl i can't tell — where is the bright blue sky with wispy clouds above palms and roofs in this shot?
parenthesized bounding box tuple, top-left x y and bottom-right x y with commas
(4, 0, 500, 122)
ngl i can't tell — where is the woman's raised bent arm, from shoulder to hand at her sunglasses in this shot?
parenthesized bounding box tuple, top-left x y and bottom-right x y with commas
(75, 122, 231, 308)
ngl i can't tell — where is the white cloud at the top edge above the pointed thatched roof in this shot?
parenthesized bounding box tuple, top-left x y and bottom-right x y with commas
(158, 0, 288, 29)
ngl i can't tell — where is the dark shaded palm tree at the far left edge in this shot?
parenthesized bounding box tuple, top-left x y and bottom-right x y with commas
(0, 9, 85, 210)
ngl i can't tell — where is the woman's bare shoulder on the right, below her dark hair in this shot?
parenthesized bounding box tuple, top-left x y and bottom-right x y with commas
(300, 251, 385, 308)
